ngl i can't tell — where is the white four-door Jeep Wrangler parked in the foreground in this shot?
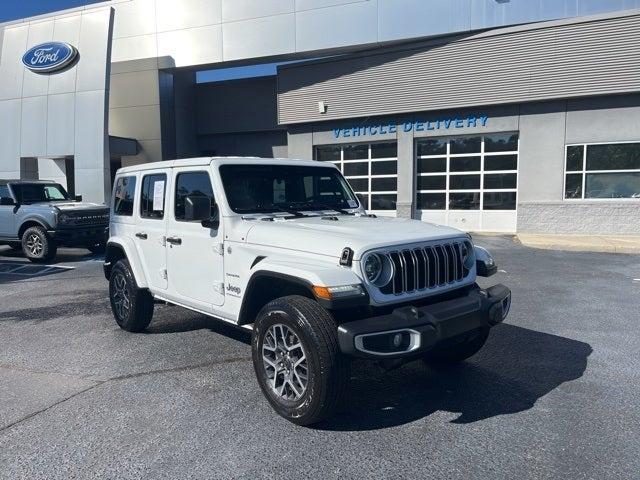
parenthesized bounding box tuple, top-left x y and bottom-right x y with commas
(104, 158, 511, 425)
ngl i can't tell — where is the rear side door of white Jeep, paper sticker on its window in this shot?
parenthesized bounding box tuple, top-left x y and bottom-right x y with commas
(133, 169, 170, 290)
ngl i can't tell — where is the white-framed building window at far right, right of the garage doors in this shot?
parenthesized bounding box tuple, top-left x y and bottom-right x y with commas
(564, 142, 640, 200)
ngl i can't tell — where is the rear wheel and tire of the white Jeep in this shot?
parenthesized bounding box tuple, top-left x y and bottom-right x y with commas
(109, 259, 153, 332)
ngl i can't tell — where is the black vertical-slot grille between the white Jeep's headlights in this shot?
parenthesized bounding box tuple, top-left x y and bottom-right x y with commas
(380, 242, 471, 295)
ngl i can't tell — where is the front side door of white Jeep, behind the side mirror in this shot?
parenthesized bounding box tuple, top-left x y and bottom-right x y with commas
(167, 167, 224, 310)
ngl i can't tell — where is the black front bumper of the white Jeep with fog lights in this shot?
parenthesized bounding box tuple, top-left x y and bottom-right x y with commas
(338, 285, 511, 359)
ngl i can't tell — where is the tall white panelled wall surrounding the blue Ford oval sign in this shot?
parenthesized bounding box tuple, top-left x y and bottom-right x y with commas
(0, 7, 112, 201)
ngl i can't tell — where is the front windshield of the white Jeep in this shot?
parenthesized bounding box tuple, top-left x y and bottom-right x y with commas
(220, 164, 359, 213)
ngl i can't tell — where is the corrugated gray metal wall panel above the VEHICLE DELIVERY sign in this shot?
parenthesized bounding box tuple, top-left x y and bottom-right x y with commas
(278, 15, 640, 124)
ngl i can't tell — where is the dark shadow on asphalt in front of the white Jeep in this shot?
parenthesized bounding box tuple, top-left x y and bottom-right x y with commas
(315, 324, 592, 431)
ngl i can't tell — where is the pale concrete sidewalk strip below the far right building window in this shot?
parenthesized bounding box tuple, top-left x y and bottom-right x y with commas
(518, 233, 640, 254)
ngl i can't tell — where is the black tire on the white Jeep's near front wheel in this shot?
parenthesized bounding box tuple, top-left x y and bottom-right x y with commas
(251, 295, 350, 425)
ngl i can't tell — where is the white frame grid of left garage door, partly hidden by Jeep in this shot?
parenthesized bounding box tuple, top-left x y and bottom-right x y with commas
(313, 140, 399, 215)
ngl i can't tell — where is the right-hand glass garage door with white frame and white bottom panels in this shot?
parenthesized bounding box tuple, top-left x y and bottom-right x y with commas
(416, 133, 518, 232)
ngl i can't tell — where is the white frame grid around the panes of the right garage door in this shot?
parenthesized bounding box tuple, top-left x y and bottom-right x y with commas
(414, 131, 520, 212)
